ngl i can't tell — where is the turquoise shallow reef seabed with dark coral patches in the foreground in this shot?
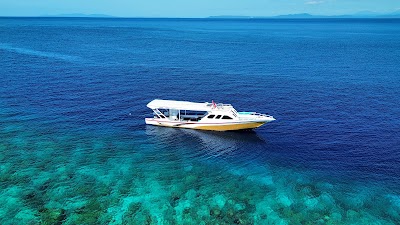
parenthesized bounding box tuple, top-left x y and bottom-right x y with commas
(0, 123, 400, 225)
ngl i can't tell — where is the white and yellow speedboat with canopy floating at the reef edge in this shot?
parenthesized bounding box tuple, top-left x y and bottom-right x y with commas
(145, 99, 275, 131)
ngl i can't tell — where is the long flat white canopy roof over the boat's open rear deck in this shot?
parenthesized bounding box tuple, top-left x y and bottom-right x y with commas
(147, 99, 232, 111)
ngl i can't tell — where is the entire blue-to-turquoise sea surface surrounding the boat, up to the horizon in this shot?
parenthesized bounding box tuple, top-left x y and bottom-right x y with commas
(0, 17, 400, 225)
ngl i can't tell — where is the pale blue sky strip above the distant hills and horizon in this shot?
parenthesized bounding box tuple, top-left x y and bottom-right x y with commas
(0, 0, 400, 18)
